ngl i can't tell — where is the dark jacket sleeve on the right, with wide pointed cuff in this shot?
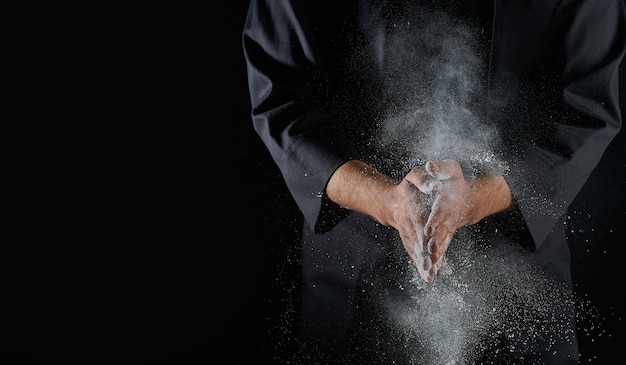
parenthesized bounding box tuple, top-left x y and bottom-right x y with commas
(494, 0, 626, 248)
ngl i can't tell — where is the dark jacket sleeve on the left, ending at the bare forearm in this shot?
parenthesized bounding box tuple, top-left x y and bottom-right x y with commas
(242, 0, 359, 232)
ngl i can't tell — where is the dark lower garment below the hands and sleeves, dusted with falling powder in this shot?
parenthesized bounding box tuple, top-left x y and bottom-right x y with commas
(297, 213, 578, 364)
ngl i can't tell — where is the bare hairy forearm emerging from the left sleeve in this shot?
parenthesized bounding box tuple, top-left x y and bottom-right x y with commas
(326, 160, 397, 226)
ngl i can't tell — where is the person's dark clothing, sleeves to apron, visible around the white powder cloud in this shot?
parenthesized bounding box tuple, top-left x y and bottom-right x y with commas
(242, 0, 626, 364)
